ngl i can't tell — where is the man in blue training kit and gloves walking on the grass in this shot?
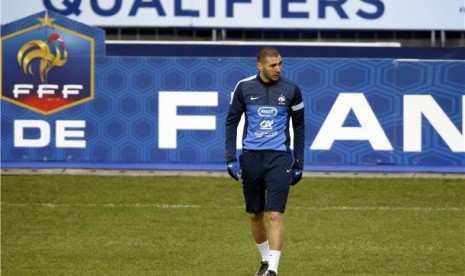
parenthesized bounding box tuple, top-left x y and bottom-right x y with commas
(225, 47, 305, 275)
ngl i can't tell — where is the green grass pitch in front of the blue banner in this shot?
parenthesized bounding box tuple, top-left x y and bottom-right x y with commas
(1, 175, 465, 276)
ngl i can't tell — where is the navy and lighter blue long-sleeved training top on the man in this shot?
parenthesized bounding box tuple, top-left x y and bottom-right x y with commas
(225, 75, 305, 162)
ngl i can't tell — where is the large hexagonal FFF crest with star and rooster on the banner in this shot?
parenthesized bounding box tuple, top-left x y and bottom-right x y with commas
(0, 12, 95, 115)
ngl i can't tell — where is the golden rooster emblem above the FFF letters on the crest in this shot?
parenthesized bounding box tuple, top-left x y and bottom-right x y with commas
(17, 33, 68, 83)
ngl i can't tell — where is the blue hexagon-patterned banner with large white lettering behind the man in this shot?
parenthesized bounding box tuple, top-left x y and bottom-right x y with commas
(1, 11, 465, 170)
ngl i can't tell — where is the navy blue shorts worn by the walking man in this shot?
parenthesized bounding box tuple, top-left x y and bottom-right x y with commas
(239, 151, 292, 213)
